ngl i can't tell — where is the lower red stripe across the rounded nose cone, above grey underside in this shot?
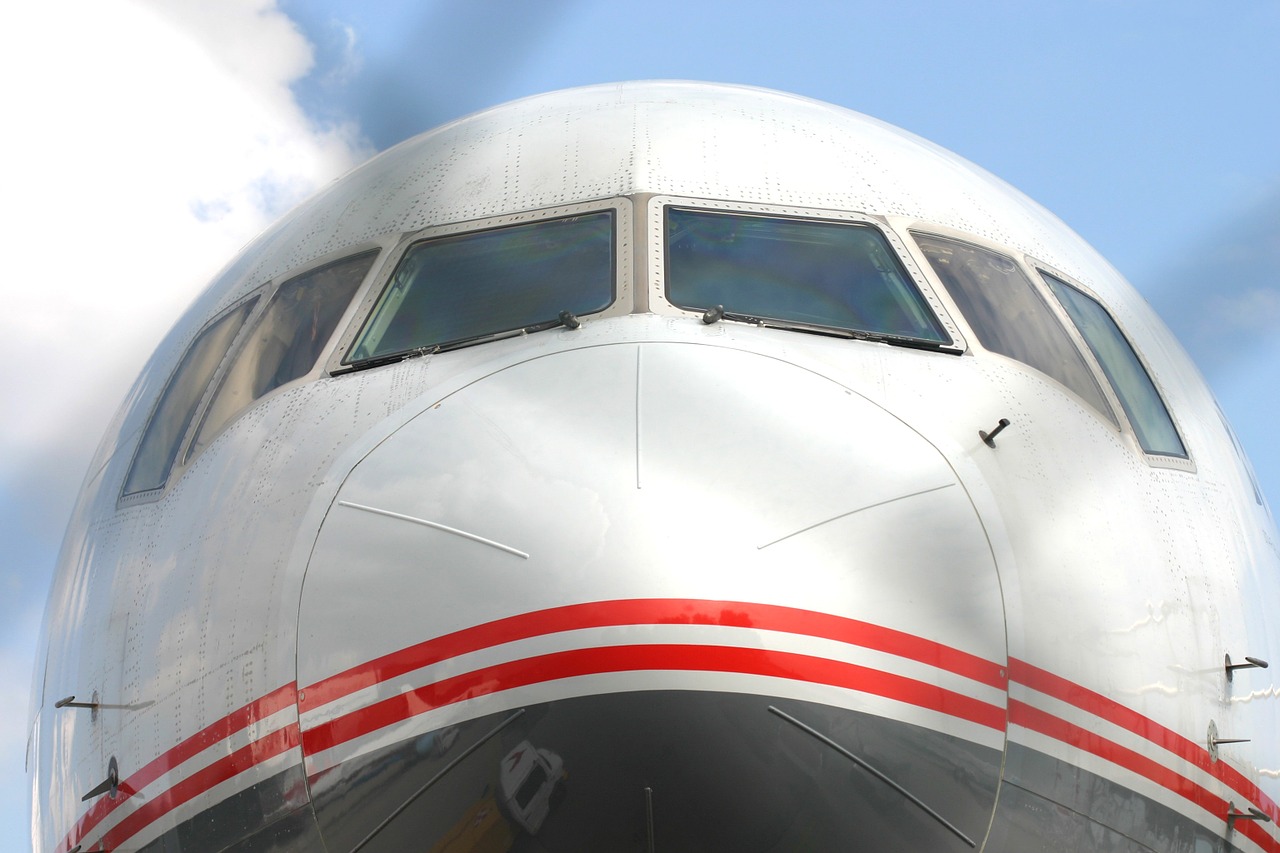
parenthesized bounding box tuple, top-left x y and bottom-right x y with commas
(302, 644, 1005, 754)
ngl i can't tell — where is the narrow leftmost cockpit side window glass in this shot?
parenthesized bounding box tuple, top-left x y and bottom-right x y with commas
(124, 297, 257, 494)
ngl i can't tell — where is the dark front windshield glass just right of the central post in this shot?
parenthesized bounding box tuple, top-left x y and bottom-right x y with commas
(666, 207, 951, 343)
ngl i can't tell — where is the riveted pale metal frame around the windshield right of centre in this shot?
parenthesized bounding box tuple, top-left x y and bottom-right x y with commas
(645, 195, 969, 356)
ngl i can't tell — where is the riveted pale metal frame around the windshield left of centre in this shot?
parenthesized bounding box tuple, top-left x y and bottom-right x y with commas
(324, 196, 635, 375)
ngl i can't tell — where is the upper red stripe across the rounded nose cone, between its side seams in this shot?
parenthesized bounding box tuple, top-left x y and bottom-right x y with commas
(298, 598, 1007, 712)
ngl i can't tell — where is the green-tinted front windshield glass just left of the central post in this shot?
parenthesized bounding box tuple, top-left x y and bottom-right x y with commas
(343, 210, 614, 365)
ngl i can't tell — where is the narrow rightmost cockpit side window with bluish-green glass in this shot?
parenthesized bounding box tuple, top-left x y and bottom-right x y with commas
(1041, 273, 1187, 457)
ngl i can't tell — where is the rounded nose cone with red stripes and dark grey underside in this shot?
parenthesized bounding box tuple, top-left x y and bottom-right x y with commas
(298, 343, 1006, 850)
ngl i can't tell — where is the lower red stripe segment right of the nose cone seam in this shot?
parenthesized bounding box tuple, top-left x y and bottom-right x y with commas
(1009, 696, 1280, 853)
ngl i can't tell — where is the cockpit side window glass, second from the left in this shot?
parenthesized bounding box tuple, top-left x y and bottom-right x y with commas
(188, 252, 378, 457)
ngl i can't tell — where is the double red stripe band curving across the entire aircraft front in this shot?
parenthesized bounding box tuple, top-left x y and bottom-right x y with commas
(58, 599, 1280, 853)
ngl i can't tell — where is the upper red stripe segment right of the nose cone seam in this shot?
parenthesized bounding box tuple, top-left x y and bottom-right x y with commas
(1009, 658, 1280, 821)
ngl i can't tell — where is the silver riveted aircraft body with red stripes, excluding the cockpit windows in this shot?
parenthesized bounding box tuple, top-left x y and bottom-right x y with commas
(29, 83, 1280, 853)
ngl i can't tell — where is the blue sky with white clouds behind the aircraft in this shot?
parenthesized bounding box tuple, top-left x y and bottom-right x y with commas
(0, 0, 1280, 849)
